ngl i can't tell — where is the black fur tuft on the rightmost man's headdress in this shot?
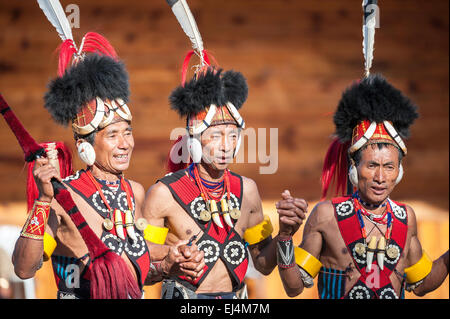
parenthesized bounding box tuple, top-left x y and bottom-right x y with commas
(334, 74, 419, 142)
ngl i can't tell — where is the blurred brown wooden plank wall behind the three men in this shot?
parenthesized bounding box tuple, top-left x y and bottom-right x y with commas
(0, 0, 449, 209)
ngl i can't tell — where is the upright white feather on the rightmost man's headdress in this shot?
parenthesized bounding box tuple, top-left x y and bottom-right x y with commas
(362, 0, 378, 77)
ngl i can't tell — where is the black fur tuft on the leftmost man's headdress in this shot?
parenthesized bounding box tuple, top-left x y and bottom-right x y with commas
(44, 54, 130, 125)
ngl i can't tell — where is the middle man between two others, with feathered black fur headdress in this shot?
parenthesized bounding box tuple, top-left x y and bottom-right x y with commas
(143, 0, 307, 299)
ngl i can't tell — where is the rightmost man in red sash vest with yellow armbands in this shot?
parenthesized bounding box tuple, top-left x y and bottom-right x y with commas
(280, 75, 449, 299)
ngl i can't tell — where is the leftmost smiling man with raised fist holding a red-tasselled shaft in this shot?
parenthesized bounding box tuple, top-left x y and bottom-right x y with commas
(13, 32, 202, 299)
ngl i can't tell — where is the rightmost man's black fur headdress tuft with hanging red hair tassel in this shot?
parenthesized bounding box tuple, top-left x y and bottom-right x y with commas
(321, 75, 418, 199)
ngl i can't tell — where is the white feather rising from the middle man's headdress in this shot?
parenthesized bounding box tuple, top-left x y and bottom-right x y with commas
(166, 0, 205, 66)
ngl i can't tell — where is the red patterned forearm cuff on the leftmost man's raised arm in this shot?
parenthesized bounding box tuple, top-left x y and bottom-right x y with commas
(20, 200, 50, 240)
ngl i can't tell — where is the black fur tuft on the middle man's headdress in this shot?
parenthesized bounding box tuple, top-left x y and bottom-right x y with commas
(169, 68, 248, 117)
